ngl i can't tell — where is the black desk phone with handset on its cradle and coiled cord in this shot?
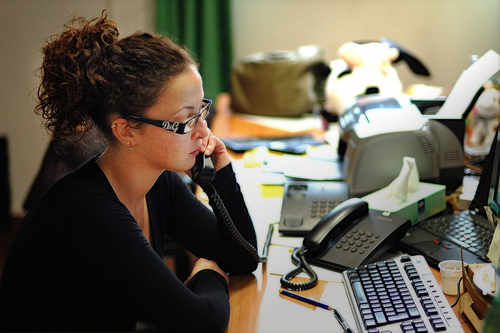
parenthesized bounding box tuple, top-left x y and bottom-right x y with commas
(281, 198, 411, 290)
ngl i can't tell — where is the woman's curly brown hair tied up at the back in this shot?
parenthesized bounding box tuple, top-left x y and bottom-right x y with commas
(35, 11, 195, 141)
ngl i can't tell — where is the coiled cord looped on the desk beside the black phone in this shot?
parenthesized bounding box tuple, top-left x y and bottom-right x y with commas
(280, 247, 318, 290)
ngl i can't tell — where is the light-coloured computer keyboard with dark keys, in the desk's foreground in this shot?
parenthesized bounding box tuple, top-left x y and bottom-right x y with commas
(342, 255, 463, 333)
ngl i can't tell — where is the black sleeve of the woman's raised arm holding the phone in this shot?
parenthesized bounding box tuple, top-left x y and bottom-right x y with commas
(167, 164, 258, 274)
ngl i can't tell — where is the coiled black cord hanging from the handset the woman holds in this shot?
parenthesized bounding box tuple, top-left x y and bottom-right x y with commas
(198, 182, 265, 262)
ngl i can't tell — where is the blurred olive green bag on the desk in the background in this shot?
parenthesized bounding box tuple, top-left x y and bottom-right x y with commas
(231, 46, 330, 116)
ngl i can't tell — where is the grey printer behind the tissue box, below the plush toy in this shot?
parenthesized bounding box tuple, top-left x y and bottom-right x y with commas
(338, 95, 464, 196)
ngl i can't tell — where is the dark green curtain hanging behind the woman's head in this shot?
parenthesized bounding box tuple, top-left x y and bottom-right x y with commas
(156, 0, 232, 98)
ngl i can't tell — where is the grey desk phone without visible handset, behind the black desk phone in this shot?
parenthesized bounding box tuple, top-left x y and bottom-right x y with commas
(279, 180, 348, 236)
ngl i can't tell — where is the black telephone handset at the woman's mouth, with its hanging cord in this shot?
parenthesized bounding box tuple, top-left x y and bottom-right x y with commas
(191, 153, 266, 262)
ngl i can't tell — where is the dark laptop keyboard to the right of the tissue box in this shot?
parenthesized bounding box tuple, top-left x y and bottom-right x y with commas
(420, 210, 493, 261)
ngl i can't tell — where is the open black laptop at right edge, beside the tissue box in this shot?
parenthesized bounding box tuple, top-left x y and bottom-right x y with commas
(400, 122, 500, 267)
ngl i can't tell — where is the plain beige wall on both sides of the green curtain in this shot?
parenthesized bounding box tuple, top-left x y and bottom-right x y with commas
(0, 0, 500, 213)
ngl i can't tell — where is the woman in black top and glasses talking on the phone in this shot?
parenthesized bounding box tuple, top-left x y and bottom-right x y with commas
(0, 13, 257, 332)
